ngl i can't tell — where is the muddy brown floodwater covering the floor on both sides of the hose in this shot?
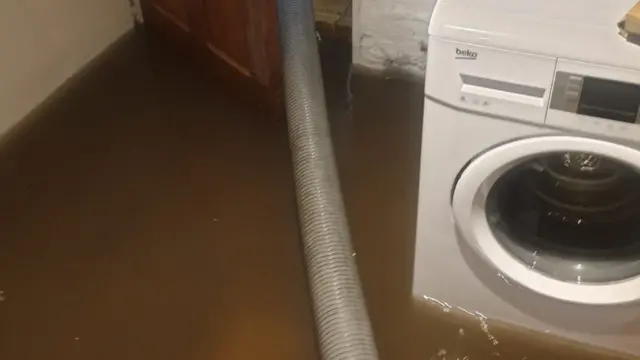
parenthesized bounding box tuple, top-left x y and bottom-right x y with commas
(0, 31, 632, 360)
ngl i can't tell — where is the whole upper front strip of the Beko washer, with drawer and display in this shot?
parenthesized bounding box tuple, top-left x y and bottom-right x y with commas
(425, 36, 640, 141)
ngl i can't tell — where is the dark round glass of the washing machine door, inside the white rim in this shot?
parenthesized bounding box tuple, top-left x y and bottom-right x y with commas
(486, 152, 640, 283)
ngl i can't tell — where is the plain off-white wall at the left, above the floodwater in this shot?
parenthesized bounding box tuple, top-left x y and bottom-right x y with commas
(0, 0, 133, 134)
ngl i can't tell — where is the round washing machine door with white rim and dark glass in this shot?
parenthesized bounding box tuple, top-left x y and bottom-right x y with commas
(452, 136, 640, 305)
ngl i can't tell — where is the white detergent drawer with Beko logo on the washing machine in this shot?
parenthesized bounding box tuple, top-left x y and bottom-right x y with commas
(425, 36, 556, 124)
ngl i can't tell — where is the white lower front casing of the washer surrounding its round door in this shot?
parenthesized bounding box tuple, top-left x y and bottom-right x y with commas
(412, 97, 640, 355)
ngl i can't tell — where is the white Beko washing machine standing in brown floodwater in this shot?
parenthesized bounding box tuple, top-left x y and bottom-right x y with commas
(413, 0, 640, 356)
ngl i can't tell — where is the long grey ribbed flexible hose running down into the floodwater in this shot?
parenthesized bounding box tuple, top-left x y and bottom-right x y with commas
(278, 0, 378, 360)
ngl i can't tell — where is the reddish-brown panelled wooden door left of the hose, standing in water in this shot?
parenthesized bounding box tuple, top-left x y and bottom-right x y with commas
(142, 0, 284, 118)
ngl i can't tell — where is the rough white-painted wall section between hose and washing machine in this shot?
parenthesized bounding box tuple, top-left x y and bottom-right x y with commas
(353, 0, 437, 79)
